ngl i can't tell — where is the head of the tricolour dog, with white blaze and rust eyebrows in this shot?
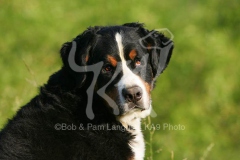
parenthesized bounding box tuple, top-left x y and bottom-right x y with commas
(61, 23, 173, 120)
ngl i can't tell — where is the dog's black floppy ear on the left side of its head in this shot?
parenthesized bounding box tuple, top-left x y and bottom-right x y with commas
(60, 27, 99, 87)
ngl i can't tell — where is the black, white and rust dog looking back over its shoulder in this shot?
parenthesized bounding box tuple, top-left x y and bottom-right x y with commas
(0, 23, 173, 160)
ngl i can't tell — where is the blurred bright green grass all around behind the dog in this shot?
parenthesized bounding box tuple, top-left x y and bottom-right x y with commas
(0, 0, 240, 160)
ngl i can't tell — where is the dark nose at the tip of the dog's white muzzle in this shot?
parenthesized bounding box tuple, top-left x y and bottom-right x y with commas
(122, 87, 142, 103)
